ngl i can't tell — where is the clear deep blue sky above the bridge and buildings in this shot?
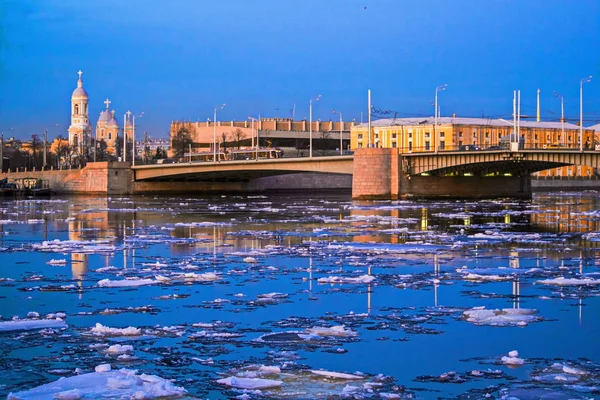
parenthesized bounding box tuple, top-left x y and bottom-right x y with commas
(0, 0, 600, 138)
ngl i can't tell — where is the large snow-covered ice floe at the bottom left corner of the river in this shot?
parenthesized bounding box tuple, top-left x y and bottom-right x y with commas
(7, 364, 187, 400)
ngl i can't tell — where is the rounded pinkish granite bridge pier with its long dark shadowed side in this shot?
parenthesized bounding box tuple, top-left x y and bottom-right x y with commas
(352, 148, 531, 200)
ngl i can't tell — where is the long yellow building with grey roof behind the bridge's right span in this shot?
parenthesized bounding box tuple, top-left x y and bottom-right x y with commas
(350, 117, 600, 176)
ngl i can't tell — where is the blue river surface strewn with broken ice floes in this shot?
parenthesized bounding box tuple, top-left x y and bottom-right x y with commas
(0, 192, 600, 399)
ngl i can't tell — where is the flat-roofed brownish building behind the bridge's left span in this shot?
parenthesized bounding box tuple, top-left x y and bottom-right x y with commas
(170, 118, 354, 157)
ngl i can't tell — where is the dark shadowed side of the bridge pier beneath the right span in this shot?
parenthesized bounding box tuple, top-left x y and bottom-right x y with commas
(400, 175, 531, 199)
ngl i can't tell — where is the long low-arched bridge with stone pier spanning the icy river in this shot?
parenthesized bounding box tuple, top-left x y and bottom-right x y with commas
(132, 148, 600, 199)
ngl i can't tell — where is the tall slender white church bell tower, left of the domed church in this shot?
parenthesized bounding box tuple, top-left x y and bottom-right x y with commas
(69, 71, 92, 154)
